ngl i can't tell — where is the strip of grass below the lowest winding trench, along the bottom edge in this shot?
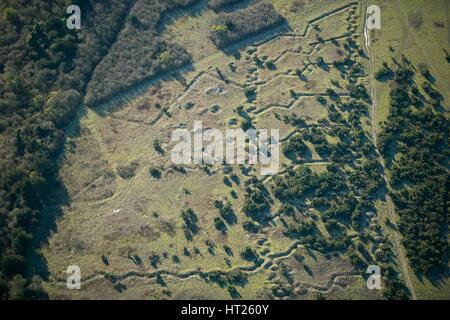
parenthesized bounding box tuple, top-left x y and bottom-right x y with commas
(45, 256, 378, 300)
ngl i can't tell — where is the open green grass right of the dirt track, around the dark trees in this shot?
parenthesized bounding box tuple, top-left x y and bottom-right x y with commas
(371, 0, 450, 299)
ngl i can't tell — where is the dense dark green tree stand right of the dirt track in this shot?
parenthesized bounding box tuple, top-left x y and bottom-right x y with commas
(379, 63, 450, 273)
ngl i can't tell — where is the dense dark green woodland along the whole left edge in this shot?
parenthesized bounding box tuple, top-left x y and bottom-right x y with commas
(0, 0, 199, 299)
